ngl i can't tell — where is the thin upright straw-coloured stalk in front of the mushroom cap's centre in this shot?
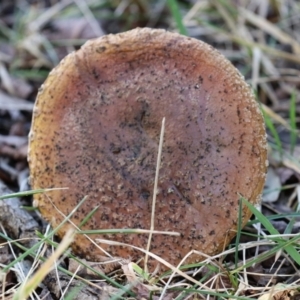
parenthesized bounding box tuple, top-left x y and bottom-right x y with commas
(144, 117, 165, 272)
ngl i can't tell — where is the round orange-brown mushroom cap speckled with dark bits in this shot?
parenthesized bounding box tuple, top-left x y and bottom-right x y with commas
(29, 28, 267, 270)
